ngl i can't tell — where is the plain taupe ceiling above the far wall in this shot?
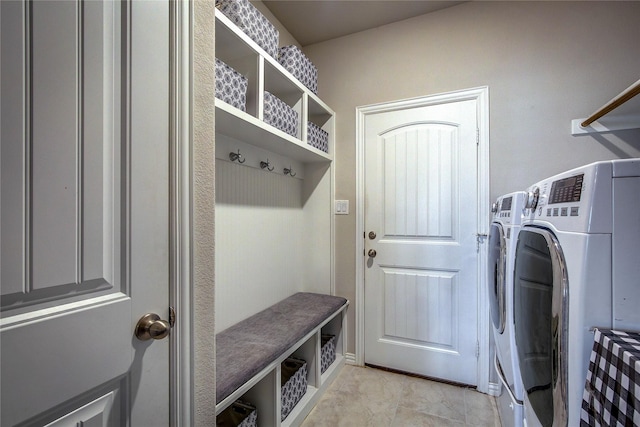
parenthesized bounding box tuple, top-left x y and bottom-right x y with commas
(263, 0, 464, 46)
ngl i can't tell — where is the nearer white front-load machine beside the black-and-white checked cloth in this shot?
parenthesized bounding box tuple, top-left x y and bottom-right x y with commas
(514, 159, 640, 427)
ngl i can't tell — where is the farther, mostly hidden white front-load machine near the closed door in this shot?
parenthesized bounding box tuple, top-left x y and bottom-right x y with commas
(487, 191, 527, 427)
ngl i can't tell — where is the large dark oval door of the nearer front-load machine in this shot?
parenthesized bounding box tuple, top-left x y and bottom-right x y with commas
(513, 227, 568, 426)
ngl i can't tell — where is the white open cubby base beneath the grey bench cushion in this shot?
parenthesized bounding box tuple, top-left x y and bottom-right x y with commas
(216, 307, 346, 427)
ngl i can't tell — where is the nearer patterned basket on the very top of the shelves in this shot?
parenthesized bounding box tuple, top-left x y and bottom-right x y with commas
(216, 0, 280, 58)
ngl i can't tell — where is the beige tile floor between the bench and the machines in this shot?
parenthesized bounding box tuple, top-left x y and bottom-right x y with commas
(302, 365, 500, 427)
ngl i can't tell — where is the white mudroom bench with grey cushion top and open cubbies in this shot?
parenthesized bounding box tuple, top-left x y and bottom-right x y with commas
(216, 292, 349, 427)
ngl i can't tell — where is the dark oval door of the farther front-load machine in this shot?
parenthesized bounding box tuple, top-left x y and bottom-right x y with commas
(487, 222, 507, 333)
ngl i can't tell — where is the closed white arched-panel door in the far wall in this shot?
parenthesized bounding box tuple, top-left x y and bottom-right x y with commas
(363, 95, 479, 385)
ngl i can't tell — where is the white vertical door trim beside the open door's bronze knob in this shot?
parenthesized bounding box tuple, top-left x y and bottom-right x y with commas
(168, 1, 195, 426)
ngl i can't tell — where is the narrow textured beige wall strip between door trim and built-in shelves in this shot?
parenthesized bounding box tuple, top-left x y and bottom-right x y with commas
(194, 1, 216, 426)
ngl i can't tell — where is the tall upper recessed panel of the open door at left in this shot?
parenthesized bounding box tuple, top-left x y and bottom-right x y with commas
(0, 2, 121, 317)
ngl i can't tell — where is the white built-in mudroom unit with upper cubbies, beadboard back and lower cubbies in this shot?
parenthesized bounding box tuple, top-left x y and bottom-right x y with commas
(215, 5, 346, 427)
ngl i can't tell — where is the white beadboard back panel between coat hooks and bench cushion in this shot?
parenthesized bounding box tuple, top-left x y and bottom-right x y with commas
(216, 160, 305, 332)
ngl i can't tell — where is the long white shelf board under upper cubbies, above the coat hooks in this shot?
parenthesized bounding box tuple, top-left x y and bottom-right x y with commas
(215, 99, 332, 163)
